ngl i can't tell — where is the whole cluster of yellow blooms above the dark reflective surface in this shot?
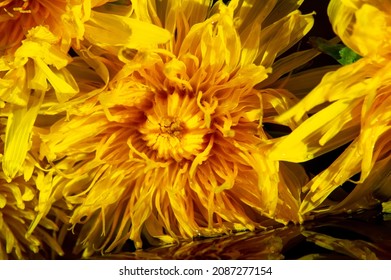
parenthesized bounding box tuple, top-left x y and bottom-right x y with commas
(0, 0, 391, 259)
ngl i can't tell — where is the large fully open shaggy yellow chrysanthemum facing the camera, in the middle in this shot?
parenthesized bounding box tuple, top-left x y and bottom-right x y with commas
(41, 0, 316, 256)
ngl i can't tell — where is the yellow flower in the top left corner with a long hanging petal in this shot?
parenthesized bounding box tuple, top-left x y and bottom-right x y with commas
(0, 0, 168, 181)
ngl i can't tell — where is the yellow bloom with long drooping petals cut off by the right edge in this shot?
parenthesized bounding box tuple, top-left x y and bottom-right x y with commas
(270, 0, 391, 218)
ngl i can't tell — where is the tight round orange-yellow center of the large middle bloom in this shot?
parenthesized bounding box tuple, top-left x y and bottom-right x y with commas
(139, 93, 208, 162)
